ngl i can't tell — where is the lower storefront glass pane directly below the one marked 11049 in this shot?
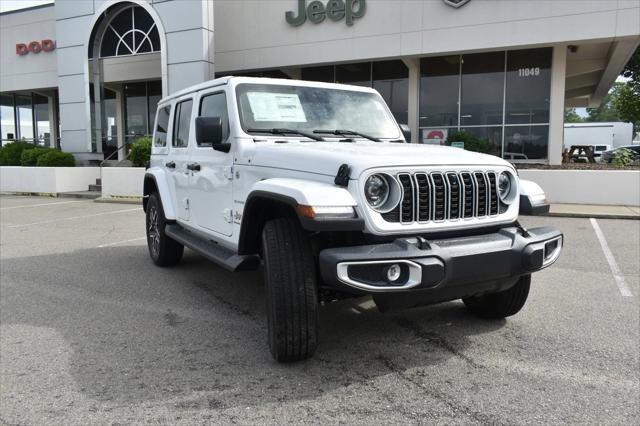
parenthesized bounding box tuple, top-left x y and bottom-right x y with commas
(502, 126, 549, 160)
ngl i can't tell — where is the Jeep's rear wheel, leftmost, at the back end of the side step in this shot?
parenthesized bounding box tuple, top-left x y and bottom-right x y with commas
(146, 192, 184, 266)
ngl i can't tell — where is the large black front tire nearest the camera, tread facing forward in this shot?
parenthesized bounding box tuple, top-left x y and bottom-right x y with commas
(262, 218, 318, 362)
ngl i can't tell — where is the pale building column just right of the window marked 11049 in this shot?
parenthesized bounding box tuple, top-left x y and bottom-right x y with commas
(547, 44, 567, 165)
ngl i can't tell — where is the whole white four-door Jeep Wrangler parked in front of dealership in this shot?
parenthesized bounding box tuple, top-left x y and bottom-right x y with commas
(144, 77, 562, 362)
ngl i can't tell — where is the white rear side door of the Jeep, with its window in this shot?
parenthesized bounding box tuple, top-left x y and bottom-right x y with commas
(165, 98, 193, 221)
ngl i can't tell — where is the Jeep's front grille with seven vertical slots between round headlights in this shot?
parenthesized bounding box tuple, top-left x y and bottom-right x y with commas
(382, 171, 503, 224)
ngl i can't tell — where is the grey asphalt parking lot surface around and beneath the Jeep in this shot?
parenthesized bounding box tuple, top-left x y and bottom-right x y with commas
(0, 196, 640, 425)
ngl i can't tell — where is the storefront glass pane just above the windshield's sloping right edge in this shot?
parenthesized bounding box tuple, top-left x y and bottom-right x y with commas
(372, 61, 409, 124)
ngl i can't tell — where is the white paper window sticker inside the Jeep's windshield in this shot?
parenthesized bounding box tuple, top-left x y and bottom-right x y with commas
(247, 92, 307, 123)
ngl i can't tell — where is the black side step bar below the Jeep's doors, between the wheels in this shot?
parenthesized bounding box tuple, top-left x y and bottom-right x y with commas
(164, 224, 260, 272)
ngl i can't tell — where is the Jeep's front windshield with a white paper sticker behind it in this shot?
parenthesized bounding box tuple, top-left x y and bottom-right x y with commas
(236, 84, 399, 139)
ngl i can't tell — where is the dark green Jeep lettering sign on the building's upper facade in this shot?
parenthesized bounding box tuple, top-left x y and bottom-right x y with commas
(284, 0, 367, 27)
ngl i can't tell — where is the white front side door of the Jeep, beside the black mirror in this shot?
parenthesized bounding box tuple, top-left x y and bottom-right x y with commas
(190, 89, 233, 236)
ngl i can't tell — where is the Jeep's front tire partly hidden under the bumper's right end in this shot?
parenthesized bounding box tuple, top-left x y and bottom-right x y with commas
(462, 275, 531, 319)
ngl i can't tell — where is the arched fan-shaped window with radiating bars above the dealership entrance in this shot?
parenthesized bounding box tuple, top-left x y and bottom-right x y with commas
(100, 6, 160, 58)
